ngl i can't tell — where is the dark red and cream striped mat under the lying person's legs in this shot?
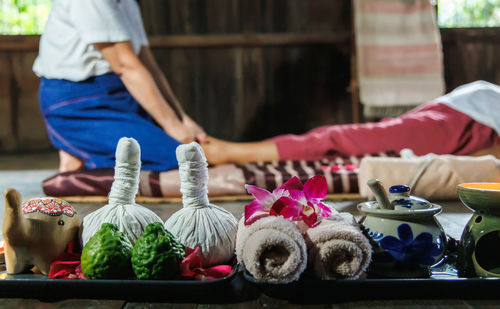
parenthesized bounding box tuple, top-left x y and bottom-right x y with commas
(43, 152, 398, 198)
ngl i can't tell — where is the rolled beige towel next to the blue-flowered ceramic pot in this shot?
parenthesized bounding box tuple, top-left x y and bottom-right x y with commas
(304, 213, 372, 280)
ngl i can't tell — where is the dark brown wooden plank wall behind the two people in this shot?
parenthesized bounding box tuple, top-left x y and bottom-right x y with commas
(0, 0, 500, 152)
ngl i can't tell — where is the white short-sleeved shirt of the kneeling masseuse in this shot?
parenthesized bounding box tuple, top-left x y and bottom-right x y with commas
(33, 0, 148, 81)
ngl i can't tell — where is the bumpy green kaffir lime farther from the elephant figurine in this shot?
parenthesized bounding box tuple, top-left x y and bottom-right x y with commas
(132, 222, 185, 280)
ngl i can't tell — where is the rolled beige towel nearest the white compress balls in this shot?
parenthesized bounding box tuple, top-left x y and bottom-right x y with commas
(236, 216, 307, 284)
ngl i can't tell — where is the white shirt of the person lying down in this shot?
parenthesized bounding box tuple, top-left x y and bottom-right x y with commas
(434, 80, 500, 135)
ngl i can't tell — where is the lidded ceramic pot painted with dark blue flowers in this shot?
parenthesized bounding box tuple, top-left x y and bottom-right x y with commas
(358, 180, 446, 276)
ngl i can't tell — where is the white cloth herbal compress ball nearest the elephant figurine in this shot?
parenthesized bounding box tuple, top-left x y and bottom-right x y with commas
(82, 137, 163, 246)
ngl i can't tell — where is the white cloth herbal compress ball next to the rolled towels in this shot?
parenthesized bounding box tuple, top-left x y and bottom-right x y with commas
(165, 142, 238, 266)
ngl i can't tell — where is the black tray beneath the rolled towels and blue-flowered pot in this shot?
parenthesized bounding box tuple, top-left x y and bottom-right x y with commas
(243, 270, 500, 304)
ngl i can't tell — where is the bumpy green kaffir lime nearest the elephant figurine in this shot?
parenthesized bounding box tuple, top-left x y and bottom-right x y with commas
(81, 223, 132, 279)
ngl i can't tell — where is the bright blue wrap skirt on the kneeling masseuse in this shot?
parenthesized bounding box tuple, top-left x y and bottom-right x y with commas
(39, 73, 180, 171)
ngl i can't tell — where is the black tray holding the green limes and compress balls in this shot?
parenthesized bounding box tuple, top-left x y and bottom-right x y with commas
(0, 265, 256, 303)
